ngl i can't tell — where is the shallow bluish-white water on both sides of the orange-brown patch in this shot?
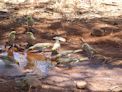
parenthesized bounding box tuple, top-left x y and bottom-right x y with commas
(0, 52, 51, 76)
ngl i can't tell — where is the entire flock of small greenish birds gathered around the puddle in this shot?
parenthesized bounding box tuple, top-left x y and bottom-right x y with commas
(0, 16, 116, 91)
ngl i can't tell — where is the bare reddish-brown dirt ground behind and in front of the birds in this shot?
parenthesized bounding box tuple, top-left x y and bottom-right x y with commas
(0, 3, 122, 92)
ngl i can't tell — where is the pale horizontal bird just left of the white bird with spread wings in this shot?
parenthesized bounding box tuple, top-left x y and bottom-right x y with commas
(28, 43, 53, 52)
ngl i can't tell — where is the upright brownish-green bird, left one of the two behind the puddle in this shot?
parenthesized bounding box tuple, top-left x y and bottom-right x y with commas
(5, 31, 16, 48)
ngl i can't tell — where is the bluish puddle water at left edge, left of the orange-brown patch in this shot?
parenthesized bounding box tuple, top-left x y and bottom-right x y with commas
(0, 52, 27, 76)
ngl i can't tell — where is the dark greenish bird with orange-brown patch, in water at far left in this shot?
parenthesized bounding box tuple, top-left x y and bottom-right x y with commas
(0, 48, 19, 66)
